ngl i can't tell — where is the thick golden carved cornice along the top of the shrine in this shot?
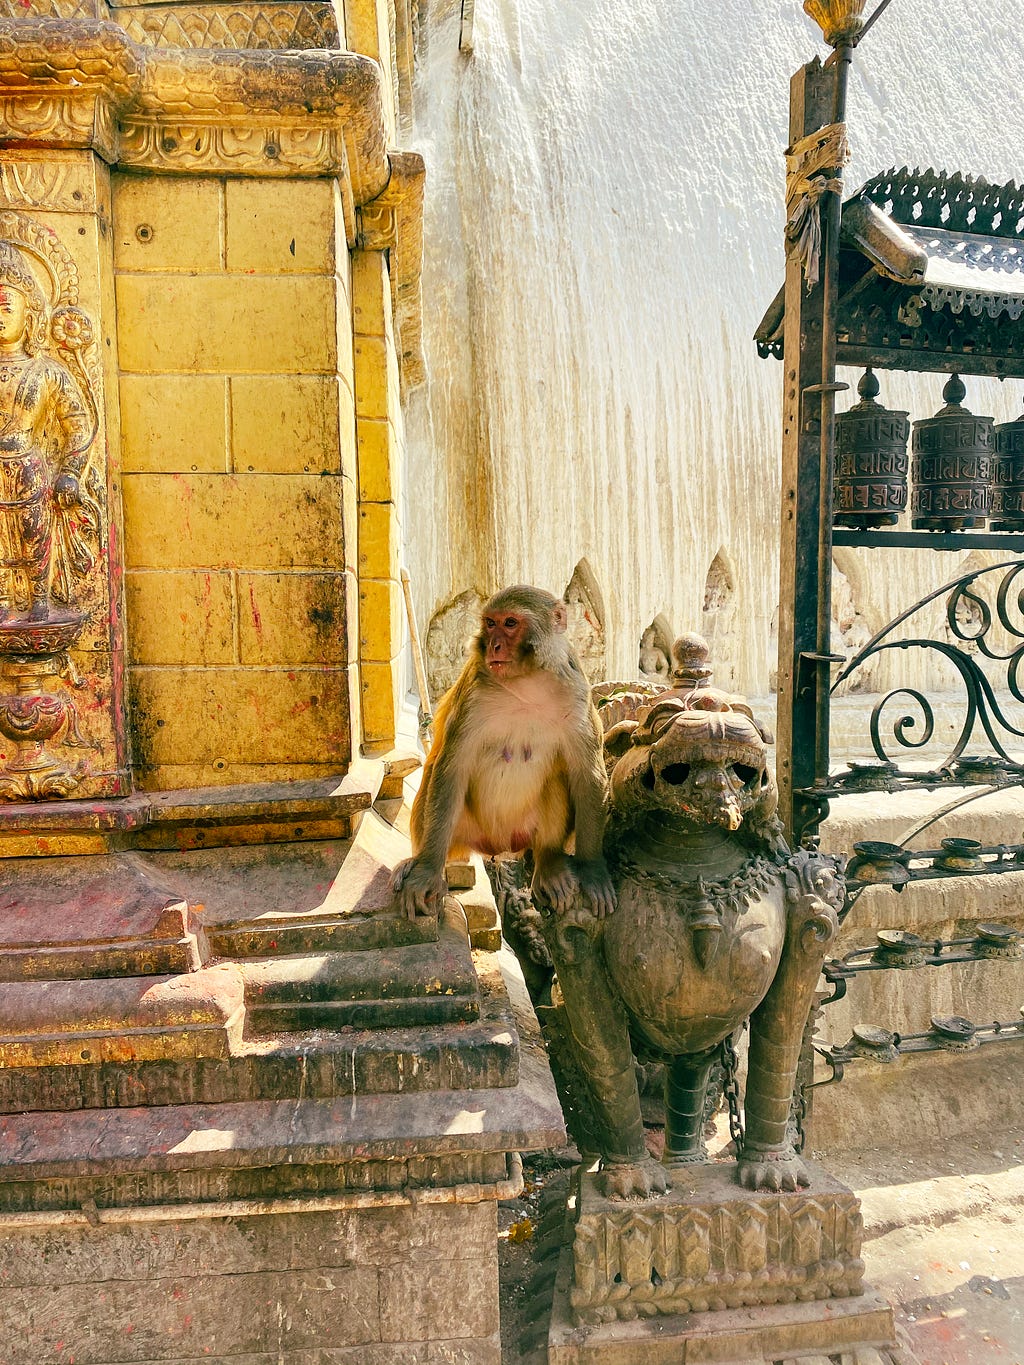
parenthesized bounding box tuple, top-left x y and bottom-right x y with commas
(0, 16, 393, 203)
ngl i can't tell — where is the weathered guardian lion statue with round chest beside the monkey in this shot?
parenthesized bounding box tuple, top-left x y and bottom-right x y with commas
(541, 636, 844, 1198)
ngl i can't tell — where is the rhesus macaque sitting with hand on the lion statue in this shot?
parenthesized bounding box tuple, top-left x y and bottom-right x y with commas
(392, 586, 614, 919)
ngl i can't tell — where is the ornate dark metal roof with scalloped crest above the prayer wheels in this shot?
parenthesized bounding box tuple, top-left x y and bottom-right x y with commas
(754, 167, 1024, 378)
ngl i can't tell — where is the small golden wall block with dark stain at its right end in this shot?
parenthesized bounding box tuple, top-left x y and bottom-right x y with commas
(238, 573, 348, 665)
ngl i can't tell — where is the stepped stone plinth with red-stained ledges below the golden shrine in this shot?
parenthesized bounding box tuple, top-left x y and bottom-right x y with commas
(0, 756, 564, 1365)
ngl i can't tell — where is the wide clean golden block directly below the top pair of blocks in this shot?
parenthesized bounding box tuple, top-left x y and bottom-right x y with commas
(117, 274, 337, 374)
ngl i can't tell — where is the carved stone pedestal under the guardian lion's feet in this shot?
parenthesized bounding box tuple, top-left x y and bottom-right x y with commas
(547, 1163, 902, 1365)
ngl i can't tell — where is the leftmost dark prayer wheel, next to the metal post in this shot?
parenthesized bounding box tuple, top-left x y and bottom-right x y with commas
(834, 367, 911, 531)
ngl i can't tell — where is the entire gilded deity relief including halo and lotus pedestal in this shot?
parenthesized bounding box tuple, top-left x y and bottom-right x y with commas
(0, 212, 101, 800)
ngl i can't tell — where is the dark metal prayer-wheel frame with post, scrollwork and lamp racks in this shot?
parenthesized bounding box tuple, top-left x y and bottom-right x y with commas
(755, 45, 1024, 1118)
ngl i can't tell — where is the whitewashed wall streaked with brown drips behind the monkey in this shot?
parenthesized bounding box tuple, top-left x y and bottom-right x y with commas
(406, 0, 1024, 695)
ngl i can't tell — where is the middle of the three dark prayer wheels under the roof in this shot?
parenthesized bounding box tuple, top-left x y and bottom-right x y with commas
(911, 374, 995, 531)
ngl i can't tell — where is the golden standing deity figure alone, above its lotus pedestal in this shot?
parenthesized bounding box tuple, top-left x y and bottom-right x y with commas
(0, 240, 98, 622)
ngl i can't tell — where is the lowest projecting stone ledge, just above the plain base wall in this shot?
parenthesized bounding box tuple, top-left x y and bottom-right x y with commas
(0, 1015, 565, 1206)
